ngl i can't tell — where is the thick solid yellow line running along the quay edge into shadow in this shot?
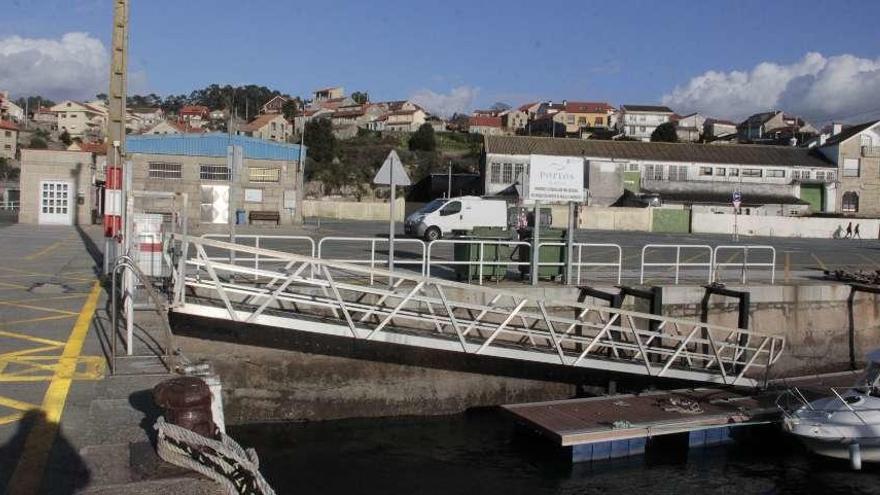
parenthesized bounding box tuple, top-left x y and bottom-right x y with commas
(6, 281, 101, 494)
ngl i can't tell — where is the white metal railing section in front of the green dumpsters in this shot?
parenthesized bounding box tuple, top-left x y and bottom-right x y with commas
(426, 239, 531, 285)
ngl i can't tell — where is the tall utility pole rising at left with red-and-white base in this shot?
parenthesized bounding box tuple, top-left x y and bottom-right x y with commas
(103, 0, 129, 271)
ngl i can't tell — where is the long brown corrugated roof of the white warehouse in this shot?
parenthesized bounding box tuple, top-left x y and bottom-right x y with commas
(484, 136, 837, 168)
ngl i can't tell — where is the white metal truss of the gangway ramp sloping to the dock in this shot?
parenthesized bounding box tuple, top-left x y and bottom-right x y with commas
(171, 235, 784, 386)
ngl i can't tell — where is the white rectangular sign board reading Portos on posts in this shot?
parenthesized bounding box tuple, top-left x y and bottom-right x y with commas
(526, 155, 584, 203)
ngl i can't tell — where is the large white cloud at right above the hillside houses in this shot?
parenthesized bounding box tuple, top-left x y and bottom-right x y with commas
(663, 52, 880, 123)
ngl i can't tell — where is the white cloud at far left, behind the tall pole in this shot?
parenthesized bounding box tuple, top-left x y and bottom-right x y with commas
(0, 32, 110, 100)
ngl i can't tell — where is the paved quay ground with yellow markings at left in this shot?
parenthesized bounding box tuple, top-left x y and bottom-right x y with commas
(0, 223, 216, 494)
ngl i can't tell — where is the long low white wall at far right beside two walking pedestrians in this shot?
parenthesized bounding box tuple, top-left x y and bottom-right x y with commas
(691, 213, 880, 239)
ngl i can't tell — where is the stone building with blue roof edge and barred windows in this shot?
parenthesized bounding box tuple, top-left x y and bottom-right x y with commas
(127, 133, 306, 226)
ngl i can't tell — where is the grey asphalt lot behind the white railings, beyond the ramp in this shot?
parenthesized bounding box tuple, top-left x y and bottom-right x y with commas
(201, 219, 880, 283)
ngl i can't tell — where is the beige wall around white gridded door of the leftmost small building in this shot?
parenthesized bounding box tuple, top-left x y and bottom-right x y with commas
(18, 149, 95, 225)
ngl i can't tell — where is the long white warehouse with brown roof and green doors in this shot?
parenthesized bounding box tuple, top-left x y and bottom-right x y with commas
(482, 136, 838, 215)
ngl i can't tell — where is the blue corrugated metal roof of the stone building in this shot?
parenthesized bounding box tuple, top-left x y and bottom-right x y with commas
(125, 132, 308, 161)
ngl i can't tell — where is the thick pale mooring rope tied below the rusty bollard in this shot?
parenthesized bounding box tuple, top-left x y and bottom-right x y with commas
(153, 417, 275, 495)
